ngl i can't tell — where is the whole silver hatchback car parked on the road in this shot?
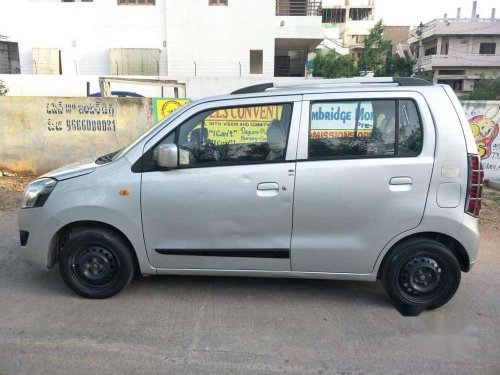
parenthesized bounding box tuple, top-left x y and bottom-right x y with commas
(19, 78, 483, 309)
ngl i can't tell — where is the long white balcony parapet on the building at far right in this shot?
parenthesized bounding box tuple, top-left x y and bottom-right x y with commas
(413, 53, 500, 71)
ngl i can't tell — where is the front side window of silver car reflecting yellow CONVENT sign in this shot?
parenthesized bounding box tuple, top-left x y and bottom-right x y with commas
(153, 104, 292, 167)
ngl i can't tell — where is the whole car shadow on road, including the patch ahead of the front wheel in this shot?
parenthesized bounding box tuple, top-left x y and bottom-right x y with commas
(11, 267, 393, 309)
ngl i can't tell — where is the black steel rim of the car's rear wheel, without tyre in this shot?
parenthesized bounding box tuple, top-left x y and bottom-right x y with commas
(396, 256, 446, 303)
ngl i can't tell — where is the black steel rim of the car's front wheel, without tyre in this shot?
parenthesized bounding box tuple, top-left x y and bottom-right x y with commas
(70, 244, 120, 289)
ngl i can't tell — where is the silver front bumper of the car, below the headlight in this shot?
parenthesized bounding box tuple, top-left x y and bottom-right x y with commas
(17, 207, 64, 269)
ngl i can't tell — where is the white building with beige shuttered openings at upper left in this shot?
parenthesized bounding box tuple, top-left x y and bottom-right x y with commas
(0, 0, 166, 75)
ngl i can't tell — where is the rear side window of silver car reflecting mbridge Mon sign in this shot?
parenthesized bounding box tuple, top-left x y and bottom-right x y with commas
(309, 99, 422, 159)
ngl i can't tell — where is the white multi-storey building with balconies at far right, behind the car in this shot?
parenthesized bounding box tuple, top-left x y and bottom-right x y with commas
(408, 2, 500, 92)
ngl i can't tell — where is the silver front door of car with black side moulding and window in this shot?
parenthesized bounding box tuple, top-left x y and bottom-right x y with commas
(141, 98, 300, 271)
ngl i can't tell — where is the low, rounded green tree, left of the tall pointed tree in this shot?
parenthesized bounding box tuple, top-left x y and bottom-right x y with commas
(313, 51, 359, 78)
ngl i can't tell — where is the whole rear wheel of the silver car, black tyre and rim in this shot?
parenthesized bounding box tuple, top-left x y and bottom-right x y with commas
(381, 238, 461, 309)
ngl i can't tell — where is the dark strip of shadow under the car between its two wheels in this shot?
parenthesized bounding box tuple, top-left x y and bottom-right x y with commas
(128, 275, 392, 308)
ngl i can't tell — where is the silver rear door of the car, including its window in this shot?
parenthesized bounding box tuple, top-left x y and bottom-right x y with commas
(291, 92, 435, 274)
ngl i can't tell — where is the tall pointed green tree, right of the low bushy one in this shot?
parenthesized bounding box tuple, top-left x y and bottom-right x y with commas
(358, 20, 391, 76)
